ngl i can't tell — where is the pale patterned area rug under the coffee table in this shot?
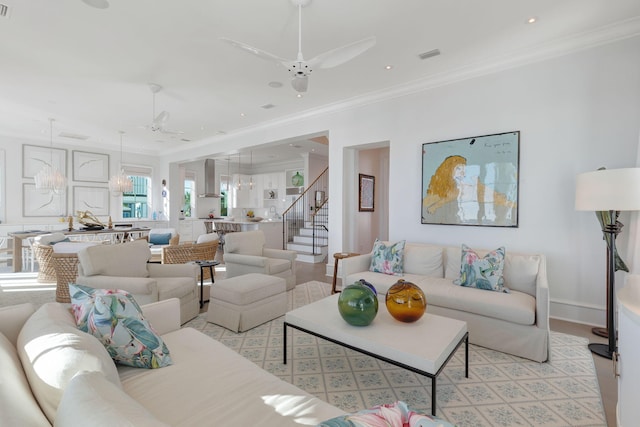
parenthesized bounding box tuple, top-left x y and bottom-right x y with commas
(186, 281, 607, 427)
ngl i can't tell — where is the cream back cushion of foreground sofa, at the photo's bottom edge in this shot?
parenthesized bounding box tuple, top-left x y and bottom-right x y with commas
(55, 372, 167, 427)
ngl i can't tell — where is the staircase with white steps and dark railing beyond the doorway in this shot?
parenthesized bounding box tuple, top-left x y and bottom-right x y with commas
(282, 168, 329, 264)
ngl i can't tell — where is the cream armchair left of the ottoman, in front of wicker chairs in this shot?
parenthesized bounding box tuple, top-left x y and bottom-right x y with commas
(77, 240, 200, 323)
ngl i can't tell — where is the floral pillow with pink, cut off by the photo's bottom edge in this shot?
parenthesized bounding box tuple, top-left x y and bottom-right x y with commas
(318, 401, 453, 427)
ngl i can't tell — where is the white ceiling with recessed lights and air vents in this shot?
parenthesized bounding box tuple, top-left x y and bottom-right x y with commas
(0, 0, 640, 160)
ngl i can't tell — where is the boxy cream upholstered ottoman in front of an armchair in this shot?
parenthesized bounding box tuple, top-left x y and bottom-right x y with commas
(207, 273, 287, 332)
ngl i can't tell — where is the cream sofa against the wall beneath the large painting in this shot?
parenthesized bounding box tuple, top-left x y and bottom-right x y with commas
(340, 242, 550, 362)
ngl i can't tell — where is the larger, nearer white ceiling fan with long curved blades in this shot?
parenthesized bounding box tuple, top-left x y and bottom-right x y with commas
(220, 0, 376, 92)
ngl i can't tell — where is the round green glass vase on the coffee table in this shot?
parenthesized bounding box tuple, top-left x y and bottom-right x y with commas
(338, 282, 378, 326)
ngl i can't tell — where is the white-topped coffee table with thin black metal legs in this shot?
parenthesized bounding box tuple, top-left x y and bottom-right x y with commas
(283, 294, 469, 415)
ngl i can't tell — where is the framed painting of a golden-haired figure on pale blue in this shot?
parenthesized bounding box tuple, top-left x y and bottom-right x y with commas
(421, 131, 520, 227)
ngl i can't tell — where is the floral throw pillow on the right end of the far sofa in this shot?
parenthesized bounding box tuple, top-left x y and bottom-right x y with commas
(453, 245, 509, 292)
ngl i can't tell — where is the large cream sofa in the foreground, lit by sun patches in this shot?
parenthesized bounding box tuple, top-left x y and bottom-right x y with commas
(0, 299, 344, 427)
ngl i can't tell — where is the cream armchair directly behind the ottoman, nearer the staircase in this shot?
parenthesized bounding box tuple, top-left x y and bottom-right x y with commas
(223, 230, 297, 290)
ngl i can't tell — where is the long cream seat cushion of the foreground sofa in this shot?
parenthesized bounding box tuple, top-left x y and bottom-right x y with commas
(118, 328, 344, 427)
